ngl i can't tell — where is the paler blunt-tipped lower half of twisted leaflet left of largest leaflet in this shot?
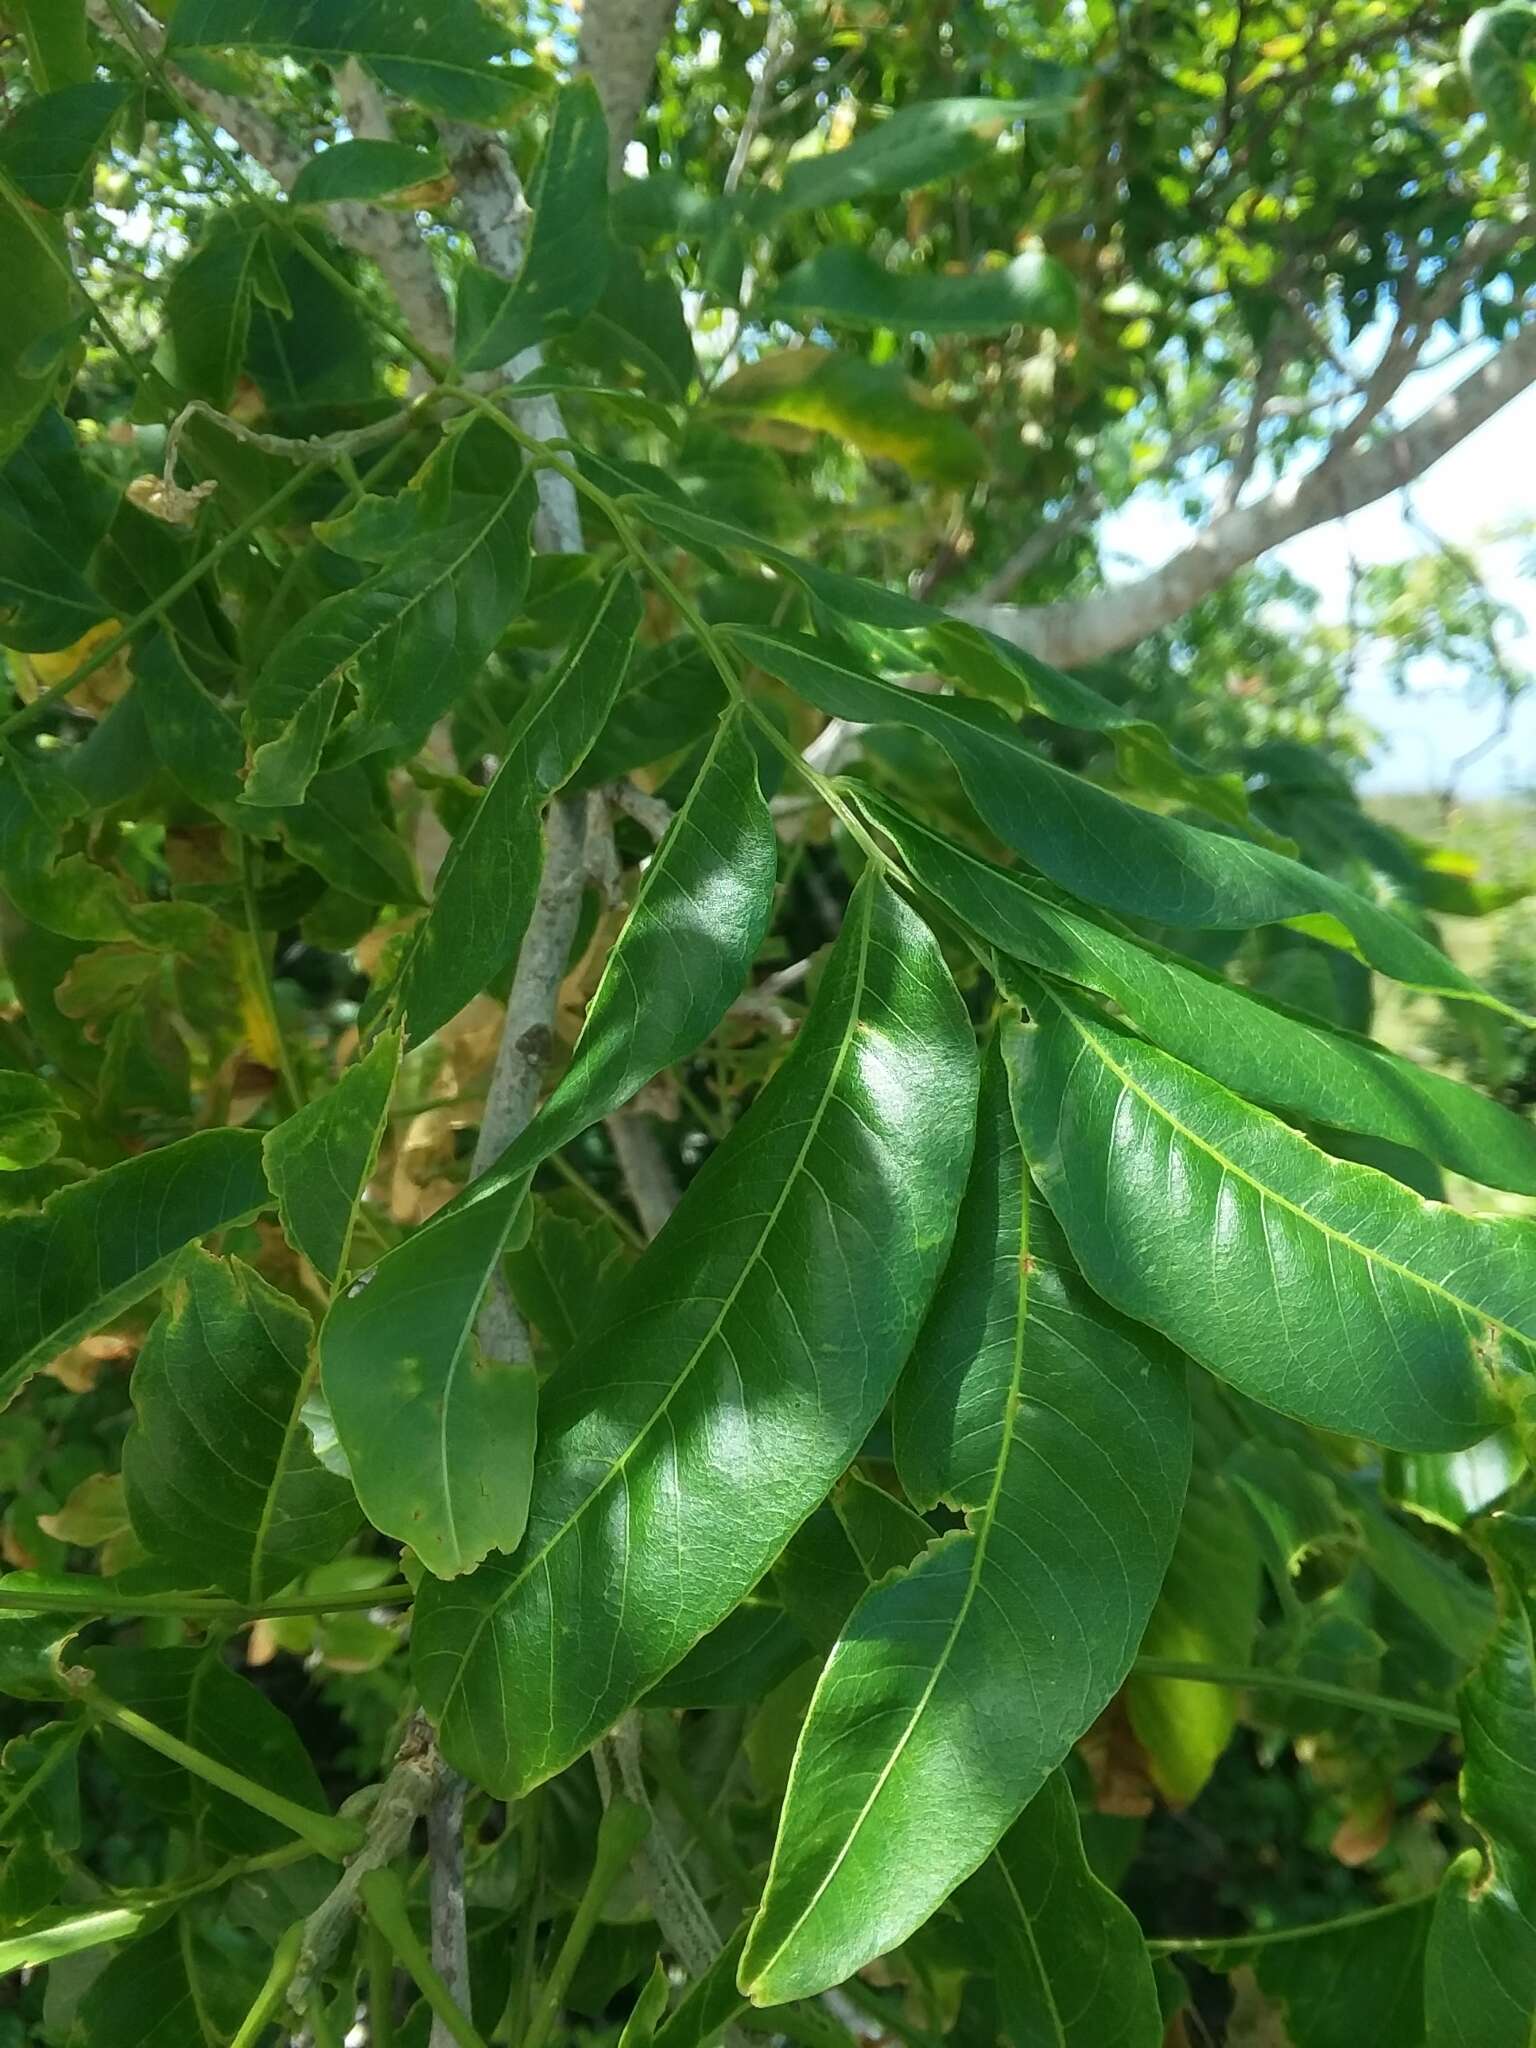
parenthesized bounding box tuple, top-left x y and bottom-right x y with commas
(319, 1190, 537, 1579)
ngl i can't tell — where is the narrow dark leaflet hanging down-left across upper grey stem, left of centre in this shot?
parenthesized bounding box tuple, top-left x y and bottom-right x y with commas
(389, 569, 641, 1044)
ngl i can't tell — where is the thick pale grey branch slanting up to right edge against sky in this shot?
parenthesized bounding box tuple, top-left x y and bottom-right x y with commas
(952, 324, 1536, 668)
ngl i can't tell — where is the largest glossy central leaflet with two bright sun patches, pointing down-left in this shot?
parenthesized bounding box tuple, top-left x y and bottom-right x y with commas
(414, 870, 975, 1796)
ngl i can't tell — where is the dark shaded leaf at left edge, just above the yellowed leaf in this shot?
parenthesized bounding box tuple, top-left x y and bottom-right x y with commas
(0, 410, 106, 653)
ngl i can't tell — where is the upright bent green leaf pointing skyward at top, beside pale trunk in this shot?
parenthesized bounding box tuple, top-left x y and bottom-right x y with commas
(455, 78, 608, 371)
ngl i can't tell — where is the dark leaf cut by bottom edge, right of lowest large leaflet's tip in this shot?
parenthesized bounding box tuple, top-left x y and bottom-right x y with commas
(958, 1772, 1163, 2048)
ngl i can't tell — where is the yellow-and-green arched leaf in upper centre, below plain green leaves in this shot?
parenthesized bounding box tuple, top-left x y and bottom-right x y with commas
(711, 344, 987, 487)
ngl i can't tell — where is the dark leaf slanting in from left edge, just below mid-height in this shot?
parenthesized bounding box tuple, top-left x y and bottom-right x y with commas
(0, 1130, 268, 1401)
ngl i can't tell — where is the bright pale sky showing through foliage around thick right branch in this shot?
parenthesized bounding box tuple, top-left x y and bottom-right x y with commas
(1106, 356, 1536, 797)
